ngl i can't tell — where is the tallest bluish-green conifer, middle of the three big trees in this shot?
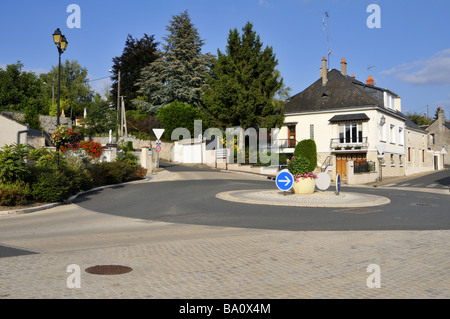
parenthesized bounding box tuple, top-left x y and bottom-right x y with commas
(136, 11, 213, 112)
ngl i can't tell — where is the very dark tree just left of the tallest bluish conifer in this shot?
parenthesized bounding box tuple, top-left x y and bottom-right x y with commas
(111, 34, 159, 110)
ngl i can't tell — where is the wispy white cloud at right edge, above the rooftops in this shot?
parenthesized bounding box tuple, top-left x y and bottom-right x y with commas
(381, 49, 450, 85)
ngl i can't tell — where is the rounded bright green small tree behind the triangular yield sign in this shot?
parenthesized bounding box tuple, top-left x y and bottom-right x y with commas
(157, 102, 201, 140)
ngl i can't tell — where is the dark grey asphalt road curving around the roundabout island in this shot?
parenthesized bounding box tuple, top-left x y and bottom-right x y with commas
(74, 163, 450, 231)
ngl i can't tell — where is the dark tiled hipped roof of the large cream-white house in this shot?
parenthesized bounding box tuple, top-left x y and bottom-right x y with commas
(285, 69, 396, 114)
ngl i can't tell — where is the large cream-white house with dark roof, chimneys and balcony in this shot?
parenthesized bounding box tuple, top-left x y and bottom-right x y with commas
(278, 58, 433, 182)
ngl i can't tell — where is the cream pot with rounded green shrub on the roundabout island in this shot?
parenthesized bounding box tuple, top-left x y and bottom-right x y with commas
(288, 156, 317, 194)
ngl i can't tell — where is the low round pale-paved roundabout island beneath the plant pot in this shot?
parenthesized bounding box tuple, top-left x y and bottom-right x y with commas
(216, 189, 391, 208)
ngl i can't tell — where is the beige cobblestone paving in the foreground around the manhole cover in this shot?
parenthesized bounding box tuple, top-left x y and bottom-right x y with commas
(0, 225, 450, 299)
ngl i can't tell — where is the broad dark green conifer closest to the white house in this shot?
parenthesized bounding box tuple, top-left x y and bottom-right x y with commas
(203, 22, 286, 128)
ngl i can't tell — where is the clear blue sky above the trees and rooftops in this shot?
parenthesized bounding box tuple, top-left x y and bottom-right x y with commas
(0, 0, 450, 119)
